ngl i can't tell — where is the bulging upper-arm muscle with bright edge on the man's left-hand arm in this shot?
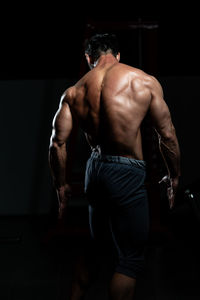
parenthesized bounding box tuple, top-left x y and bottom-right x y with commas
(51, 100, 73, 145)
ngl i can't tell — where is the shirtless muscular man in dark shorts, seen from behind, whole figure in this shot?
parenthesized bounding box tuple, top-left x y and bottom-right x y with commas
(49, 34, 180, 300)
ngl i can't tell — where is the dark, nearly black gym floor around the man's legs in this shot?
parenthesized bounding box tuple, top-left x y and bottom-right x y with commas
(0, 203, 200, 300)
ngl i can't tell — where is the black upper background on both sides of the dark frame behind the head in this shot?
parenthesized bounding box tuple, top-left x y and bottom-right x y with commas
(0, 6, 200, 79)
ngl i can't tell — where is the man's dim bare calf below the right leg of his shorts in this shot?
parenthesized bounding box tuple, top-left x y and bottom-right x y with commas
(109, 272, 136, 300)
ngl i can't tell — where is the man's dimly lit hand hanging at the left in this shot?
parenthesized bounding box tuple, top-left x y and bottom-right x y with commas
(57, 184, 71, 220)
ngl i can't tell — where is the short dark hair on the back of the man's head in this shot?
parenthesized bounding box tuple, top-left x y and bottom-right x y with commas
(85, 33, 119, 60)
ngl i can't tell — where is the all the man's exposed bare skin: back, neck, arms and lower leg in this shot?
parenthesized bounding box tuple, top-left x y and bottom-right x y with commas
(49, 53, 180, 300)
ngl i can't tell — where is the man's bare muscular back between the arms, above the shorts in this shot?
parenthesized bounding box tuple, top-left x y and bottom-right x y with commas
(64, 61, 152, 159)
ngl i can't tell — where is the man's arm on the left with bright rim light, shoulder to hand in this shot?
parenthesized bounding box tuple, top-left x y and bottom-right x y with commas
(49, 90, 73, 218)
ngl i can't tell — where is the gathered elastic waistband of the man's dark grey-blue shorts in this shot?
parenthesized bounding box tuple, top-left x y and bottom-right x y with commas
(91, 151, 146, 170)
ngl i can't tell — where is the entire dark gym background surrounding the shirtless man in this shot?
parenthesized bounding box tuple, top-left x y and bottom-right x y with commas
(0, 5, 200, 300)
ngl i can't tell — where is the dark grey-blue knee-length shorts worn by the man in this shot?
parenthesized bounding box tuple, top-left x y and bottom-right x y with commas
(85, 151, 149, 278)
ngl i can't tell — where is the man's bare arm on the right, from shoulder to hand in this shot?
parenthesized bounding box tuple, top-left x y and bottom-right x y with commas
(150, 78, 181, 207)
